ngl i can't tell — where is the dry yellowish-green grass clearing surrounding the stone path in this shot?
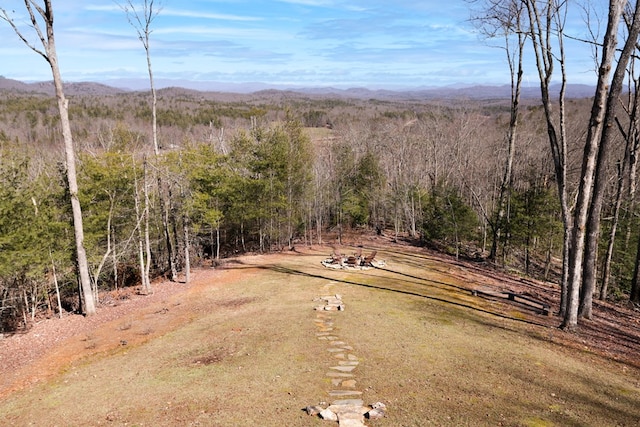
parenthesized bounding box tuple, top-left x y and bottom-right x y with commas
(0, 246, 640, 427)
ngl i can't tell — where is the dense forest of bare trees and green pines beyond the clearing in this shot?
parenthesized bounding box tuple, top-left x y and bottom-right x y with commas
(0, 81, 638, 331)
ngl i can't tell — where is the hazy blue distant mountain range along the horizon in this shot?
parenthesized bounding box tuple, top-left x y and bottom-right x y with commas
(0, 77, 595, 101)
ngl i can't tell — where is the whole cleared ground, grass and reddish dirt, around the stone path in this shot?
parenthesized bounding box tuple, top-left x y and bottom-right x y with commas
(0, 236, 640, 426)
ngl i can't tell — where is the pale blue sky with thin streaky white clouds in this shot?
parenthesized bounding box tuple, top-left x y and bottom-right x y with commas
(0, 0, 606, 89)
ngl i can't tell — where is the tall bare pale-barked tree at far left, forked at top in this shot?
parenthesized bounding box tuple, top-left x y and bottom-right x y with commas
(0, 0, 96, 316)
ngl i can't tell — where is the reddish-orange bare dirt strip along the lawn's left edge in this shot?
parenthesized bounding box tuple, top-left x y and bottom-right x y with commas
(0, 269, 234, 398)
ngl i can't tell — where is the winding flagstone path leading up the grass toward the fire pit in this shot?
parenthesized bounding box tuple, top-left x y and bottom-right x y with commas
(306, 282, 386, 427)
